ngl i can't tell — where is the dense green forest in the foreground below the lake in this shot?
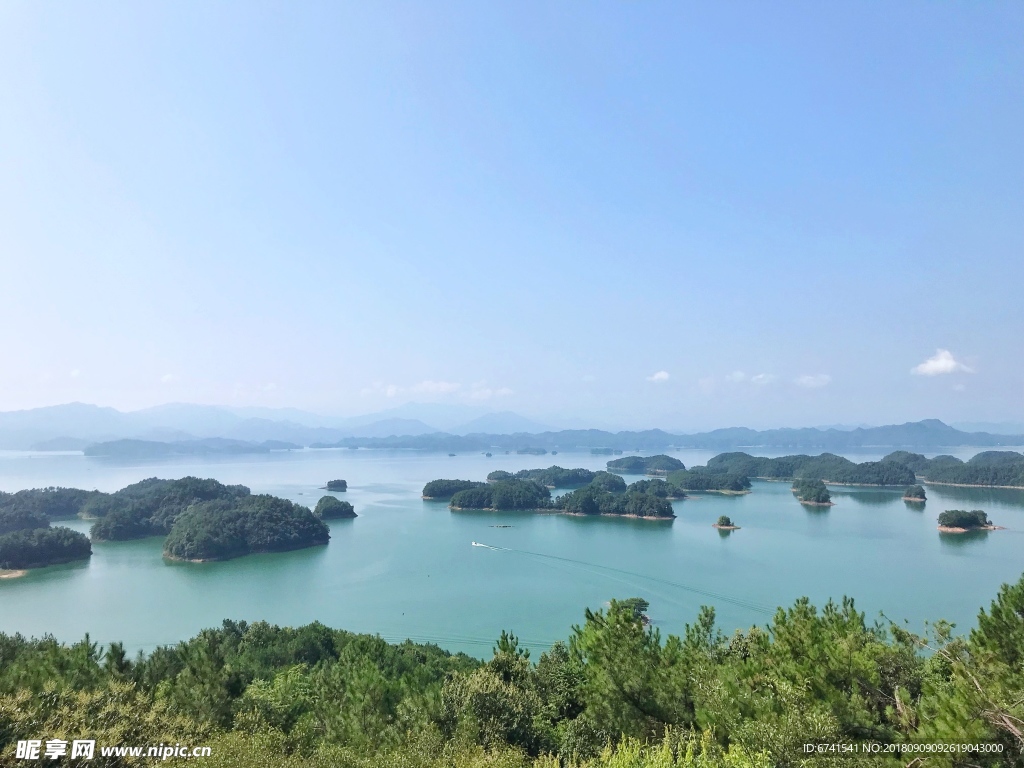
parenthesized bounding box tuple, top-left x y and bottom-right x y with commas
(0, 578, 1024, 768)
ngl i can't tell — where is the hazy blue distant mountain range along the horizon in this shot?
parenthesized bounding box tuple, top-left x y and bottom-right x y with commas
(0, 402, 1024, 456)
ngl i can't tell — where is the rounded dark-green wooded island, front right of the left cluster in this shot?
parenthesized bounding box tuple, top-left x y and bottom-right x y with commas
(164, 494, 331, 562)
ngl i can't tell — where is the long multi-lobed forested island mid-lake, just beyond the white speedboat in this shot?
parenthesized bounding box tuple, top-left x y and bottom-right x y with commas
(423, 467, 684, 519)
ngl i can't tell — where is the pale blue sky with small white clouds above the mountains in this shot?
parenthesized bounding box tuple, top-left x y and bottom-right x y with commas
(0, 0, 1024, 429)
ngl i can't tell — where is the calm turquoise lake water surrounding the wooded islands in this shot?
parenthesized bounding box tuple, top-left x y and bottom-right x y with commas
(0, 450, 1024, 655)
